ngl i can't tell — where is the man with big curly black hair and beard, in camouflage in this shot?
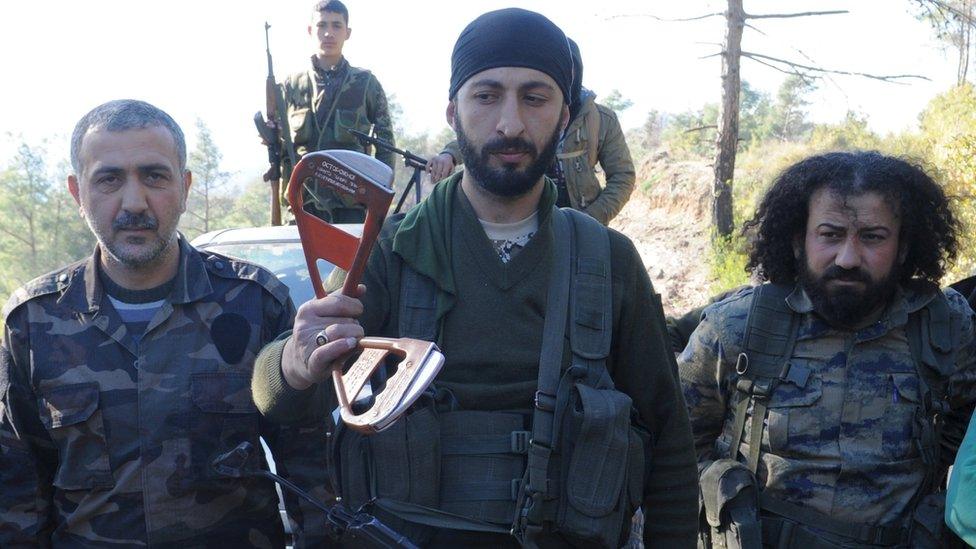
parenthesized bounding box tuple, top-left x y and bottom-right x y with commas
(678, 152, 976, 549)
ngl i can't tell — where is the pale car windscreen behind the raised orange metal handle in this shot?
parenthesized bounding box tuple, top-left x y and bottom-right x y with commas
(203, 242, 335, 307)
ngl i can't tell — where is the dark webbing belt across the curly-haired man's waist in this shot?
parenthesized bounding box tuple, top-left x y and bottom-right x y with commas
(759, 493, 908, 547)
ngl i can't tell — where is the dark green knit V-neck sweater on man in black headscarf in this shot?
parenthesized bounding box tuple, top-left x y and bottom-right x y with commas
(253, 177, 698, 547)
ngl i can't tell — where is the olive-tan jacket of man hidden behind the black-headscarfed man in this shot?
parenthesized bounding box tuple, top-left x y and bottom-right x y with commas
(441, 90, 636, 225)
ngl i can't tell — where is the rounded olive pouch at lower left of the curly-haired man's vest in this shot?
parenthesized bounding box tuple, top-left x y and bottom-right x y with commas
(699, 459, 762, 549)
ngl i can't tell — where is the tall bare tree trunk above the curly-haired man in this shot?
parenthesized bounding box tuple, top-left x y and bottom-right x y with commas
(712, 0, 746, 236)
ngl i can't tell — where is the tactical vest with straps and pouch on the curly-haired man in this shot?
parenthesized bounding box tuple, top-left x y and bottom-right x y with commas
(700, 284, 960, 549)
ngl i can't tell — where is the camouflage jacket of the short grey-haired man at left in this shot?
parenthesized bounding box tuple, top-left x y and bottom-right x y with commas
(0, 238, 325, 548)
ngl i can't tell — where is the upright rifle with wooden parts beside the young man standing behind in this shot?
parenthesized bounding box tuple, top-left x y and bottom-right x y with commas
(254, 21, 298, 225)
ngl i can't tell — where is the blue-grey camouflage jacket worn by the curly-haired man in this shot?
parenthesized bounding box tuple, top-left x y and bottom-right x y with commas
(678, 282, 976, 525)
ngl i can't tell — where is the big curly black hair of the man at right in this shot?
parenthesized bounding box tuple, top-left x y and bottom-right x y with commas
(743, 151, 960, 285)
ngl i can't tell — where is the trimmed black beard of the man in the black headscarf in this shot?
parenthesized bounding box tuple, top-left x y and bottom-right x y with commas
(454, 114, 562, 198)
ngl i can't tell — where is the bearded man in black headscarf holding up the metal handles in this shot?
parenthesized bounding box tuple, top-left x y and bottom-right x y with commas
(253, 8, 698, 547)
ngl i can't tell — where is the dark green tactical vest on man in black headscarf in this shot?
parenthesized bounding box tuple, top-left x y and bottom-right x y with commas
(330, 208, 650, 547)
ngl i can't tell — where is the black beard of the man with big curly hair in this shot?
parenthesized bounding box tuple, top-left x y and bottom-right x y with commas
(797, 251, 900, 327)
